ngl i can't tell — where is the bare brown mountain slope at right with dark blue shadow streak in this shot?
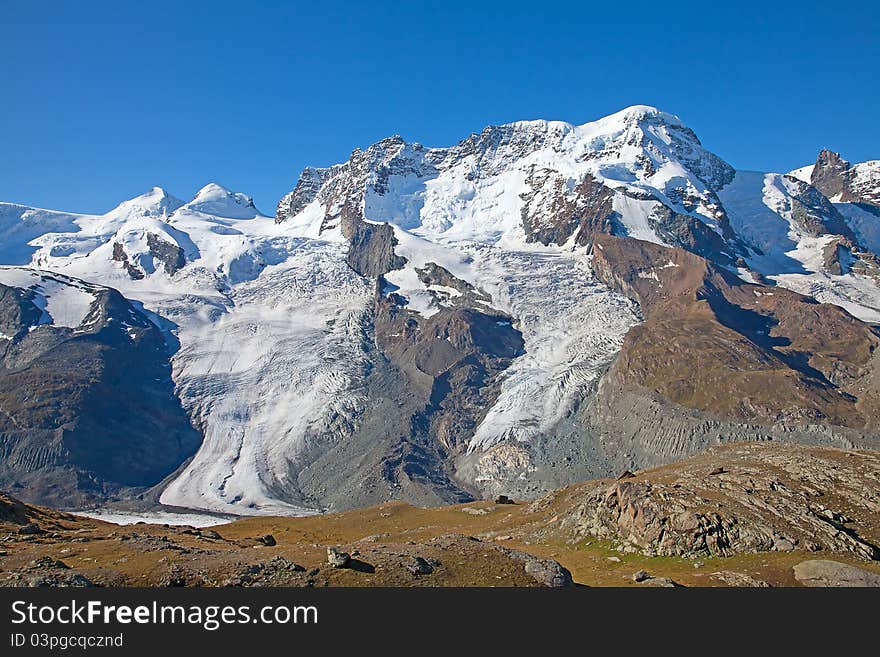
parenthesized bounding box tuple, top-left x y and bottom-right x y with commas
(594, 235, 880, 431)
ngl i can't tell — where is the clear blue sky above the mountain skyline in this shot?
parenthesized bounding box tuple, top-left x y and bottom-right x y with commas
(0, 0, 880, 214)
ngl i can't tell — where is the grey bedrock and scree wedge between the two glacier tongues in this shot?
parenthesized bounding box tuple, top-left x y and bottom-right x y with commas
(276, 288, 522, 510)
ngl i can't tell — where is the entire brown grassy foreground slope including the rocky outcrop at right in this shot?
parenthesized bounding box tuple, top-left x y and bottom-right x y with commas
(0, 443, 880, 586)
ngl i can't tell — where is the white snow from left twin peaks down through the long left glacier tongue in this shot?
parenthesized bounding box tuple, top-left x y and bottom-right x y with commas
(0, 184, 372, 515)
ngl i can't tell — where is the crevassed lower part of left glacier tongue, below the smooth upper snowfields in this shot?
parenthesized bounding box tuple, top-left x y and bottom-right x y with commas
(161, 241, 371, 515)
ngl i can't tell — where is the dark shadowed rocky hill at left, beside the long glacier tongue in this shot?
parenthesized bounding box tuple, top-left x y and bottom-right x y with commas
(0, 274, 200, 508)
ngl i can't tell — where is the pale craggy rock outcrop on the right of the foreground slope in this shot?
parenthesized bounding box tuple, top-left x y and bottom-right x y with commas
(548, 443, 880, 559)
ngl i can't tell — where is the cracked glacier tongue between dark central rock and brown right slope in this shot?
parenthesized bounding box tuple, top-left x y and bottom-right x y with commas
(468, 247, 639, 450)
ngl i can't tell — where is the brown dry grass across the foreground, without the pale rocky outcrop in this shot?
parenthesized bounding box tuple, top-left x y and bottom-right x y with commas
(6, 489, 880, 586)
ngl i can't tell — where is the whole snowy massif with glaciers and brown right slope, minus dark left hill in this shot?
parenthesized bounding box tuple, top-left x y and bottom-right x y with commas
(0, 106, 880, 513)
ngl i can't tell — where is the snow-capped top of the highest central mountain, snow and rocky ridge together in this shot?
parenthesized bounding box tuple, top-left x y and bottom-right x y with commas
(277, 106, 734, 246)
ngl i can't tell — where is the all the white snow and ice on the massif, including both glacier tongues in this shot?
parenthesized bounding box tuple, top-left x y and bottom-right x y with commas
(0, 106, 880, 515)
